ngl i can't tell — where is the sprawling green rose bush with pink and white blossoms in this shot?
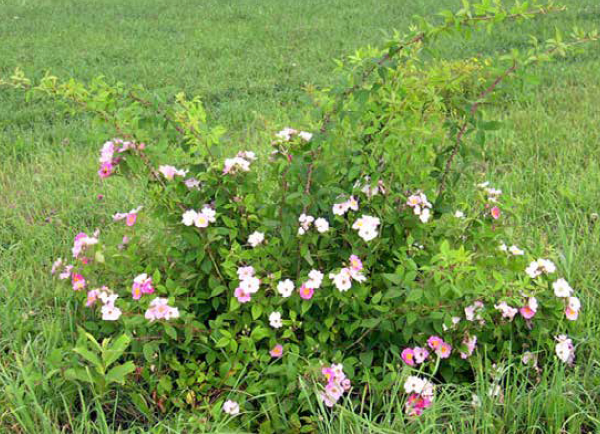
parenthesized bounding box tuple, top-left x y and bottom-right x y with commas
(3, 1, 597, 428)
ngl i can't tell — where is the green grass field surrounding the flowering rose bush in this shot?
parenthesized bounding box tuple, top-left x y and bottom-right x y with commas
(0, 0, 600, 433)
